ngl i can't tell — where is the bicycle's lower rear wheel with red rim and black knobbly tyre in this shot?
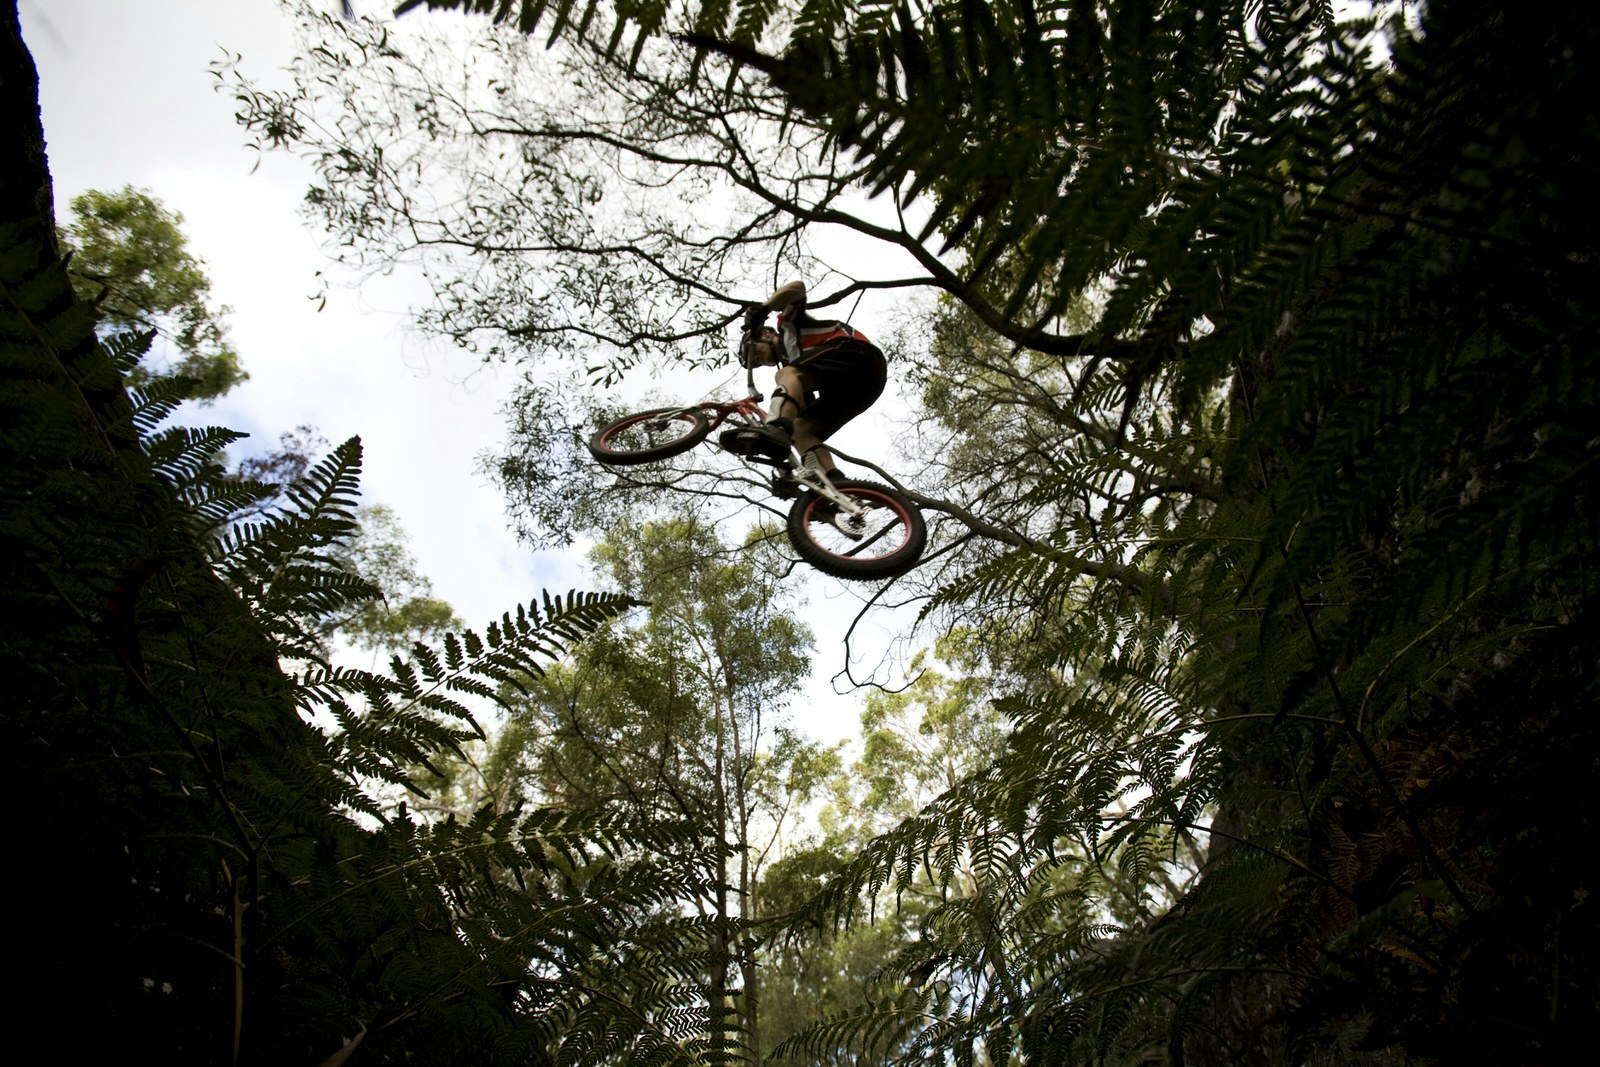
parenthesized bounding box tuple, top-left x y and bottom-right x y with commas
(789, 480, 928, 581)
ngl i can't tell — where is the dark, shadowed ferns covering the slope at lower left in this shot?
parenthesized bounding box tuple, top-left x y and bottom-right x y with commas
(0, 123, 742, 1064)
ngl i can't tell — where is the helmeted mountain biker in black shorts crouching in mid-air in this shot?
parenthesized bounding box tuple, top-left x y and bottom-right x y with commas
(739, 282, 888, 483)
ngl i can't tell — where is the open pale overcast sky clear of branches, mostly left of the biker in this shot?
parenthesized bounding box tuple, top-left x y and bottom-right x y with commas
(19, 0, 928, 737)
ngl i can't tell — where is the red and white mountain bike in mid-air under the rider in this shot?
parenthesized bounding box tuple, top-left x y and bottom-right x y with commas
(589, 337, 928, 579)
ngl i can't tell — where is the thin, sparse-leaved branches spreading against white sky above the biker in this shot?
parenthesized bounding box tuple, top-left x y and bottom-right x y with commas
(222, 3, 1049, 566)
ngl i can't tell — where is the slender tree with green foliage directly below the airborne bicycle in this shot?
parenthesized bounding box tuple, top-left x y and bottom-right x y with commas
(490, 518, 829, 1062)
